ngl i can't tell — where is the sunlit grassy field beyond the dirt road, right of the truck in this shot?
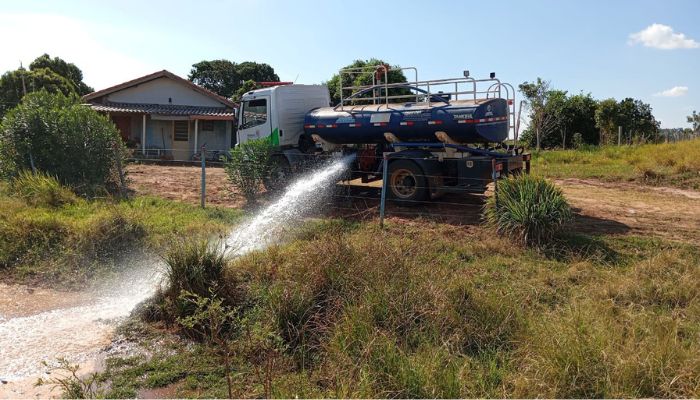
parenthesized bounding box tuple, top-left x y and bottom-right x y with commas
(532, 139, 700, 190)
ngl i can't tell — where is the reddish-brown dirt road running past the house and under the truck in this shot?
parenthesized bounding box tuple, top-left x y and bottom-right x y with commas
(128, 165, 700, 244)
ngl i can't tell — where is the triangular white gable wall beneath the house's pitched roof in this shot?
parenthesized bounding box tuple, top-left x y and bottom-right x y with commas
(107, 77, 224, 107)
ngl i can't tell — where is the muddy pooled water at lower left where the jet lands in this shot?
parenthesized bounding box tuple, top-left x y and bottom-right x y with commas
(0, 255, 161, 398)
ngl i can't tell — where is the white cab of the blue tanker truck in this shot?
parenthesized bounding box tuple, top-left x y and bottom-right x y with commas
(236, 85, 330, 151)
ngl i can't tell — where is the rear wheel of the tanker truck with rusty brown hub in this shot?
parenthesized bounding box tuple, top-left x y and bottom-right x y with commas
(388, 160, 429, 202)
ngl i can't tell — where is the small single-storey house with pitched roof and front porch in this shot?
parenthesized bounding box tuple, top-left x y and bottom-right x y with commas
(83, 70, 236, 160)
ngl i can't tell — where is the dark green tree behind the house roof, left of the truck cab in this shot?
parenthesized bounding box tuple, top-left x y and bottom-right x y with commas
(187, 60, 279, 98)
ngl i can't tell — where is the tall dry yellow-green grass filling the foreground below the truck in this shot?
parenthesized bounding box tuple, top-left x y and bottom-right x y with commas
(105, 220, 700, 398)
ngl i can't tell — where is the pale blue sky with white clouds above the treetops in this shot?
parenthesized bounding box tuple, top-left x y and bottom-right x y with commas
(0, 0, 700, 128)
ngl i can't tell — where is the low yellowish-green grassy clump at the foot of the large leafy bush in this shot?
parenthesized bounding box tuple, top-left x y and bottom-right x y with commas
(10, 171, 78, 207)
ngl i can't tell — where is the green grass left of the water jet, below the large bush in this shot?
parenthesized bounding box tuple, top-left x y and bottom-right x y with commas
(0, 183, 241, 285)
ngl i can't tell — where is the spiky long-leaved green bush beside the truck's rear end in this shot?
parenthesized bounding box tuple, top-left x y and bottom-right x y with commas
(485, 175, 572, 245)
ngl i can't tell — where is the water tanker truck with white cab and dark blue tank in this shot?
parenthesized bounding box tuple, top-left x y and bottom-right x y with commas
(237, 65, 530, 202)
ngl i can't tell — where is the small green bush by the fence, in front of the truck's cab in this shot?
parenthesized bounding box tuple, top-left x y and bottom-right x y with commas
(224, 138, 273, 202)
